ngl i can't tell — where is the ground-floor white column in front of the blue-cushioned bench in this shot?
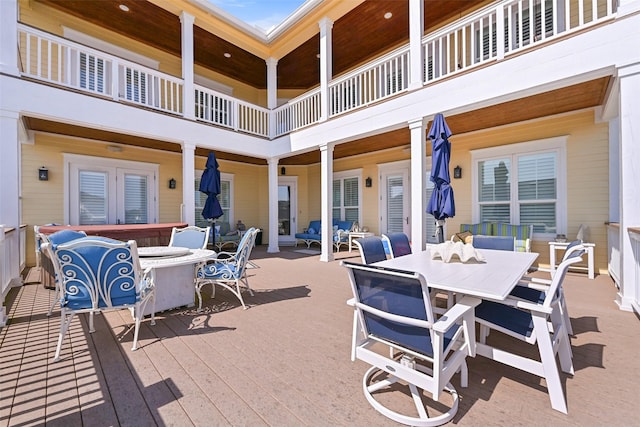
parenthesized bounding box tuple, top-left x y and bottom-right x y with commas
(320, 144, 334, 262)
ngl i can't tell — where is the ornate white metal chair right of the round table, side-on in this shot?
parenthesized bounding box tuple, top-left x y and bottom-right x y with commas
(195, 227, 260, 311)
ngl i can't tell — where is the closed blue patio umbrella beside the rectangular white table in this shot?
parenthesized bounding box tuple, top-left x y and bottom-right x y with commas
(427, 113, 456, 243)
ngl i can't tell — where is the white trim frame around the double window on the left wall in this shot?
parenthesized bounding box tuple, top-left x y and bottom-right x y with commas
(62, 153, 160, 224)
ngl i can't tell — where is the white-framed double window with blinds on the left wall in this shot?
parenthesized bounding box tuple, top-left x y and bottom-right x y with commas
(64, 154, 158, 225)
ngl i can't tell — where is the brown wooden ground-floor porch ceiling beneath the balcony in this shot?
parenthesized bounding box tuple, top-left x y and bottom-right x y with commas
(24, 77, 610, 165)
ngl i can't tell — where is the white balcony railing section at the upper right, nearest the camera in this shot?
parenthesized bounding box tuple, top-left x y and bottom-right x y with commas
(422, 0, 616, 83)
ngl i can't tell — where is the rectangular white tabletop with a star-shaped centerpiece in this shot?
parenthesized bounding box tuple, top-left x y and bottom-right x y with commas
(373, 248, 538, 301)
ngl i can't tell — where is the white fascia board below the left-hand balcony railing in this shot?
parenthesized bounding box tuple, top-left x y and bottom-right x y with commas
(0, 75, 269, 158)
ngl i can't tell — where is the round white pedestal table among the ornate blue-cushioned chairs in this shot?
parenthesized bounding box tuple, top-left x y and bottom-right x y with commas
(138, 246, 216, 315)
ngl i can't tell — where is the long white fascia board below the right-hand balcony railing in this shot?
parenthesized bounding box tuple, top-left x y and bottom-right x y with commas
(272, 15, 640, 157)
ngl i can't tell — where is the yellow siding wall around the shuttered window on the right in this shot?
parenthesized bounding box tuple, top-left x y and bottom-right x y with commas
(447, 110, 609, 274)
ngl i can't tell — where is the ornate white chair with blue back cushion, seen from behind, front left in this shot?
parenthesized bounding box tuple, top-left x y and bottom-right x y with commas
(42, 236, 155, 361)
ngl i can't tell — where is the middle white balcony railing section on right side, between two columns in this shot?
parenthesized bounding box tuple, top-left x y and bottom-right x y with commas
(329, 46, 409, 116)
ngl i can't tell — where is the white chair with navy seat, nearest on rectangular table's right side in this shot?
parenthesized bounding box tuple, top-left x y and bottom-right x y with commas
(476, 250, 584, 414)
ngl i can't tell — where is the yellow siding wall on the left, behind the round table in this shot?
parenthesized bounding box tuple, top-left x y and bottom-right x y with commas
(21, 133, 268, 265)
